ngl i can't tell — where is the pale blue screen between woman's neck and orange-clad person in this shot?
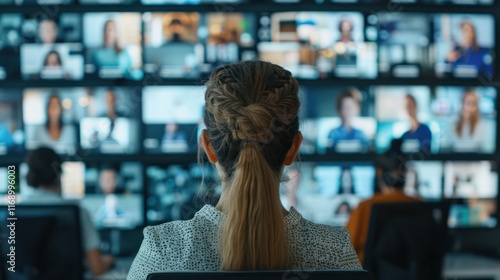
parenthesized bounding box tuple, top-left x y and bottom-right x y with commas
(281, 162, 375, 226)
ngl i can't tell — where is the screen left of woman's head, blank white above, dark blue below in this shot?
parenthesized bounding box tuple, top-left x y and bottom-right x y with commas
(142, 86, 205, 153)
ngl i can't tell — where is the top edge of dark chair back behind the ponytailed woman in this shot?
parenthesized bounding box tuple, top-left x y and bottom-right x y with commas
(147, 270, 374, 280)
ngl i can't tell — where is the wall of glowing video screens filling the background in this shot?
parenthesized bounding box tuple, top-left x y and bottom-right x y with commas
(0, 0, 500, 232)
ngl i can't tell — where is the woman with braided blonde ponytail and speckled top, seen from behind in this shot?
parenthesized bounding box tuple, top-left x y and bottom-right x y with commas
(128, 61, 361, 279)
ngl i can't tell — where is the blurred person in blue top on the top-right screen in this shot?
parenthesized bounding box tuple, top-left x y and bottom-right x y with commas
(446, 21, 493, 77)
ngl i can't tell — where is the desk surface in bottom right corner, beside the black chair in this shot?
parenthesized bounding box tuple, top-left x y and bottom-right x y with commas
(443, 253, 500, 280)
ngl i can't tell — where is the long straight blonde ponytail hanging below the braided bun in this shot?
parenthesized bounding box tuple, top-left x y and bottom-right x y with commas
(221, 142, 289, 270)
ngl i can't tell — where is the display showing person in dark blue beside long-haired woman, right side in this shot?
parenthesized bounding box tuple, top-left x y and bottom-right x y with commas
(375, 86, 496, 154)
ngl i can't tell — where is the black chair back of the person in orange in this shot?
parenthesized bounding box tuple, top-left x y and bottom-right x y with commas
(364, 202, 449, 280)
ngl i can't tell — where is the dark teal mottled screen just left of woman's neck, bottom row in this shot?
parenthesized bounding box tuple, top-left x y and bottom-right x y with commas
(146, 164, 221, 224)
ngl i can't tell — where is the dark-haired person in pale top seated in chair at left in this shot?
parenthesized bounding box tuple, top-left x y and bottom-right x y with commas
(21, 147, 114, 276)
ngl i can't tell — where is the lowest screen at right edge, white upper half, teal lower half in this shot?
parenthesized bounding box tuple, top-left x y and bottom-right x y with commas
(444, 161, 498, 227)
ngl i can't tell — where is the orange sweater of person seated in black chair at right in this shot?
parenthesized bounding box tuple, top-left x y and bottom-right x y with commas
(346, 191, 420, 264)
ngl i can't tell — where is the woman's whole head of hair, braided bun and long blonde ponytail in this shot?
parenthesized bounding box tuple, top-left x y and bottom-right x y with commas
(205, 61, 300, 270)
